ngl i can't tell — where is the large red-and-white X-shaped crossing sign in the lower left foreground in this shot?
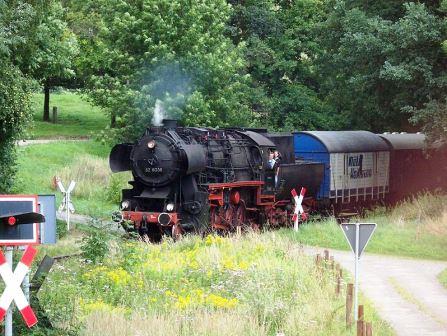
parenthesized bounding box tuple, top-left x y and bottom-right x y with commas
(0, 246, 37, 328)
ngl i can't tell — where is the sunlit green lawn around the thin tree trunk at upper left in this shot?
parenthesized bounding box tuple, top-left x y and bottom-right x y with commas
(28, 91, 108, 139)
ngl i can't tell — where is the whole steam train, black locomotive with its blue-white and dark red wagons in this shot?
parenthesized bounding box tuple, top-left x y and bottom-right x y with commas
(110, 120, 447, 241)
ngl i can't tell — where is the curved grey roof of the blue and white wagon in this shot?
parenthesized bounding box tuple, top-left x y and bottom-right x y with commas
(295, 131, 390, 153)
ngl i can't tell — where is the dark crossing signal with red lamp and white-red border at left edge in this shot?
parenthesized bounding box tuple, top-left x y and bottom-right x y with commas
(0, 195, 40, 245)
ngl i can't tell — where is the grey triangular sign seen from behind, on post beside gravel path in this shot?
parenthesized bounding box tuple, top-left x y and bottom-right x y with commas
(341, 223, 377, 322)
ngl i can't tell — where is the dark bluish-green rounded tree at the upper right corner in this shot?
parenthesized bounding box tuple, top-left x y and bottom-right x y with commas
(318, 1, 447, 132)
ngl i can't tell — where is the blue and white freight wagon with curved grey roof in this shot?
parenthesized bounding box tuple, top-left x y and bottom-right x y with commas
(294, 131, 390, 205)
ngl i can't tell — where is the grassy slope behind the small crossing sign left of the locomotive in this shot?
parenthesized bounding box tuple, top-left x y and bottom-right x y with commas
(14, 140, 126, 218)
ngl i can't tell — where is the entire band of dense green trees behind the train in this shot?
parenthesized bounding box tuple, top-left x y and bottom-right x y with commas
(0, 0, 447, 190)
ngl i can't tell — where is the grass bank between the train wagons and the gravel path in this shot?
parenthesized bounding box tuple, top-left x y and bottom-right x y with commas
(281, 195, 447, 260)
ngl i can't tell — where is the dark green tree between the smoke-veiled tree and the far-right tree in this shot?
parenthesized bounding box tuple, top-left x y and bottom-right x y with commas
(228, 0, 340, 130)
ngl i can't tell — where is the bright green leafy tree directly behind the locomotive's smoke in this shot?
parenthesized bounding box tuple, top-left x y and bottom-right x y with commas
(72, 0, 254, 139)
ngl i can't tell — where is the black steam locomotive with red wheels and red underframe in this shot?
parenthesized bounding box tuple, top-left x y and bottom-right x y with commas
(110, 120, 324, 241)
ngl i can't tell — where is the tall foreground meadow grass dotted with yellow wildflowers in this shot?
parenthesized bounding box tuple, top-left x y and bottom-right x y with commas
(30, 232, 394, 336)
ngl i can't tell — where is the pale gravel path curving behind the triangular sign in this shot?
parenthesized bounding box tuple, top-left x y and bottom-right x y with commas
(304, 247, 447, 336)
